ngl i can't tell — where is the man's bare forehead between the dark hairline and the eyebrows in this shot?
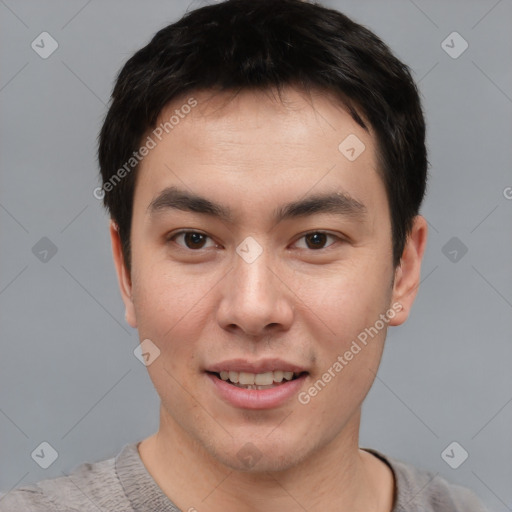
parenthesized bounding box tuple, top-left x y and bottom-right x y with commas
(136, 88, 385, 224)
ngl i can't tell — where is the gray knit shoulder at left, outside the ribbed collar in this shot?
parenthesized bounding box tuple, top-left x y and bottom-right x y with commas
(0, 447, 131, 512)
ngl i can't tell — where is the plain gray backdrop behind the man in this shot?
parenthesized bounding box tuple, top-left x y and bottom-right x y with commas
(0, 0, 512, 511)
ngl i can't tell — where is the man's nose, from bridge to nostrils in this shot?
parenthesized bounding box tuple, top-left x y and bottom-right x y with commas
(217, 245, 294, 338)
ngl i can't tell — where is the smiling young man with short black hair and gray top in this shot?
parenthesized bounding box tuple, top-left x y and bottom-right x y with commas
(0, 0, 483, 512)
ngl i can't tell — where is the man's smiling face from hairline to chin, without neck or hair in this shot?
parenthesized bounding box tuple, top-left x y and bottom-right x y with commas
(112, 88, 422, 470)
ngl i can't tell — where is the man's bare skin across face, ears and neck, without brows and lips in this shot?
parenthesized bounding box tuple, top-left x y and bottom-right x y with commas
(110, 87, 427, 512)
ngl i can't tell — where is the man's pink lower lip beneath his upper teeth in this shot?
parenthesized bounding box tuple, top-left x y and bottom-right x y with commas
(206, 373, 307, 409)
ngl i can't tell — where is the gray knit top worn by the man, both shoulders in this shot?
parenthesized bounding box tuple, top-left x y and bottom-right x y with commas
(0, 443, 486, 512)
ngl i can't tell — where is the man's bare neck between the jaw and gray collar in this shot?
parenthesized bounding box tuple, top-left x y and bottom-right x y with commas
(138, 409, 394, 512)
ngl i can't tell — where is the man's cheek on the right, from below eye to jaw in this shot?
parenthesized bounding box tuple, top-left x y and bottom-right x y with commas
(302, 256, 394, 400)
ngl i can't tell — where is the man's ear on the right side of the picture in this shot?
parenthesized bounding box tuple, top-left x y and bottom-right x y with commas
(389, 215, 428, 325)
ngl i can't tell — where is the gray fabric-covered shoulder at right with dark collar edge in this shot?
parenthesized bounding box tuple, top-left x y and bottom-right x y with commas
(367, 450, 487, 512)
